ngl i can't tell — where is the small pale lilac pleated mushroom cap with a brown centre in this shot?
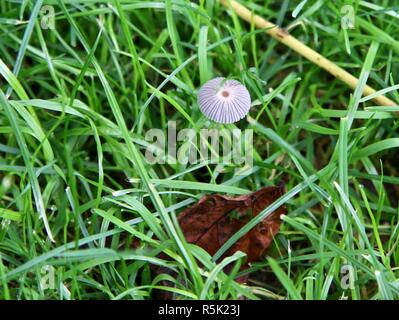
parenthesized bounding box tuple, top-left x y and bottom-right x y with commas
(198, 77, 251, 123)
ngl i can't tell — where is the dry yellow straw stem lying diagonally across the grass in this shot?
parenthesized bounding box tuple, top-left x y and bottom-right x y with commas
(220, 0, 397, 106)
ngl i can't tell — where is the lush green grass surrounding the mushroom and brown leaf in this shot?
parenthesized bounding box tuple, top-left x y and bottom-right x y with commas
(0, 0, 399, 300)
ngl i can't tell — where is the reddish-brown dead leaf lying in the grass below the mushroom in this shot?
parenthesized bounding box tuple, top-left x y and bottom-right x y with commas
(178, 187, 287, 263)
